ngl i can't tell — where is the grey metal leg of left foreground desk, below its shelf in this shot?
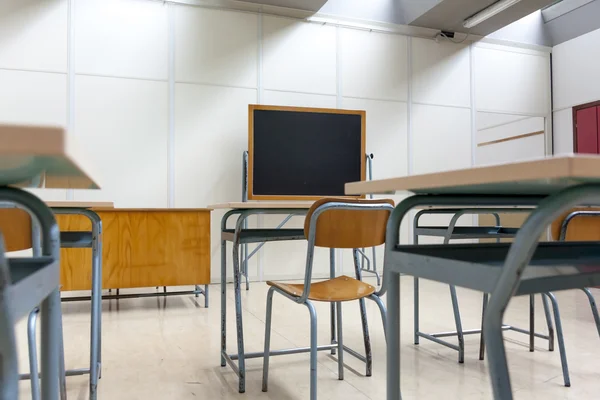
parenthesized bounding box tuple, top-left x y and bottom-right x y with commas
(41, 289, 64, 400)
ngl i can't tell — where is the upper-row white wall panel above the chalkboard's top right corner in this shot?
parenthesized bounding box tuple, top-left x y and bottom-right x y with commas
(340, 28, 408, 101)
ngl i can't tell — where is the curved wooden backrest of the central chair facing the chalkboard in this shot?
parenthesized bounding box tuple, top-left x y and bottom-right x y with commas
(304, 198, 394, 249)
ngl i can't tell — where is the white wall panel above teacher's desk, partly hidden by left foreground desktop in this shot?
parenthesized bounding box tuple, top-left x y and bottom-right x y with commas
(74, 76, 169, 208)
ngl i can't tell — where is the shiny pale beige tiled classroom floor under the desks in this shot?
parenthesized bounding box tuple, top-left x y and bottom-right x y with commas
(17, 277, 600, 400)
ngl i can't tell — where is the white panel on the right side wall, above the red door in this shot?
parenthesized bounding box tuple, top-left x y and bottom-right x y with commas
(552, 29, 600, 110)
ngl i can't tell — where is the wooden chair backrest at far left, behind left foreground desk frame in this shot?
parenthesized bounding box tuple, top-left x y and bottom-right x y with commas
(0, 208, 32, 251)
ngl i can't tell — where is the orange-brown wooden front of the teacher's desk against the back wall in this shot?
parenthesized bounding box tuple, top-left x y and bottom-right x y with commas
(57, 208, 210, 290)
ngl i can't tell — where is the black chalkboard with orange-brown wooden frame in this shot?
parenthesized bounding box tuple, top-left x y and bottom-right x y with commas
(248, 106, 365, 200)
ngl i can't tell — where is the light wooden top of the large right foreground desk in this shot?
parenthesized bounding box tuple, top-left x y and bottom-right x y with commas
(346, 155, 600, 195)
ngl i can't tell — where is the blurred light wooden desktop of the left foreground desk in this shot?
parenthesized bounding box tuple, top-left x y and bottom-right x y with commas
(0, 124, 100, 189)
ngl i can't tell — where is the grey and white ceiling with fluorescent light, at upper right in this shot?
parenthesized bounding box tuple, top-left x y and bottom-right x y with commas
(239, 0, 600, 46)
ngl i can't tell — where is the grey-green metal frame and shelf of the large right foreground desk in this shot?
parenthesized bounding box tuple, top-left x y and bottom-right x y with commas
(380, 188, 600, 400)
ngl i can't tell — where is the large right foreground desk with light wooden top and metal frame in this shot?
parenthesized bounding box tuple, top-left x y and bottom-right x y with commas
(346, 156, 600, 400)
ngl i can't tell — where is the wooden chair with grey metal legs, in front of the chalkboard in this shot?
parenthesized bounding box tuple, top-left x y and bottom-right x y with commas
(262, 199, 394, 400)
